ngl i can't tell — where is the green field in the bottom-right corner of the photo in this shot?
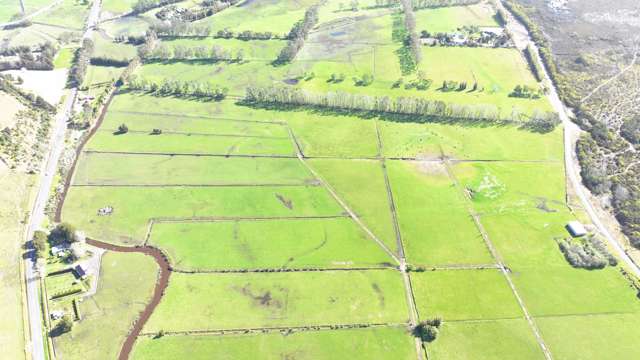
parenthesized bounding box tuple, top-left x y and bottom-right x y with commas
(536, 314, 640, 360)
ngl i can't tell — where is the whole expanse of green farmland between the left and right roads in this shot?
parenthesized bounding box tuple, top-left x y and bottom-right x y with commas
(0, 0, 640, 360)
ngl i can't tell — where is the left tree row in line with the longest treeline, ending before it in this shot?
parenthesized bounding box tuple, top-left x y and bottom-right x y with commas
(128, 75, 229, 101)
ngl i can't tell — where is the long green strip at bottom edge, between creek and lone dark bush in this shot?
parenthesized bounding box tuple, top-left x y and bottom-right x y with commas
(131, 327, 416, 360)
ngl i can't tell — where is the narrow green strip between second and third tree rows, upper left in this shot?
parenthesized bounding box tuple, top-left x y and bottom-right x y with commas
(162, 37, 287, 62)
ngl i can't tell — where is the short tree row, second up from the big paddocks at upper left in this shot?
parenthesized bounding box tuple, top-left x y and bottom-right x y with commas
(144, 44, 244, 62)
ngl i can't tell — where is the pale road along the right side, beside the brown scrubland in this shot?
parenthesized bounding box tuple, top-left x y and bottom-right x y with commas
(497, 1, 640, 277)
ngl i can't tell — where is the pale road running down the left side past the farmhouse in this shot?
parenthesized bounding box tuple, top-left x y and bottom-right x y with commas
(25, 0, 102, 360)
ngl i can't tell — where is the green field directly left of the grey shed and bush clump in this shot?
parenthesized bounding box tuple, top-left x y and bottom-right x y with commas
(481, 209, 574, 267)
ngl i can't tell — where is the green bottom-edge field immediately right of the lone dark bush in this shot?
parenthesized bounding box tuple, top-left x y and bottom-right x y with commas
(426, 319, 545, 360)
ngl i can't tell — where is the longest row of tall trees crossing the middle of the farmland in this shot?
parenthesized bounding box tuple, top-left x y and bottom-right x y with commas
(244, 86, 558, 124)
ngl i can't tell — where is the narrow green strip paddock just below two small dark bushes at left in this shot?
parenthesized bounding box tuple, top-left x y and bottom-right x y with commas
(86, 131, 295, 156)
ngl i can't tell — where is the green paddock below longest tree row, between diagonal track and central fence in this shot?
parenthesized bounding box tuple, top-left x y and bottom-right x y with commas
(286, 111, 378, 157)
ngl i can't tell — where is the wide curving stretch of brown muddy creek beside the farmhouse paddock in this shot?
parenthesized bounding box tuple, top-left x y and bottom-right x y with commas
(87, 239, 171, 360)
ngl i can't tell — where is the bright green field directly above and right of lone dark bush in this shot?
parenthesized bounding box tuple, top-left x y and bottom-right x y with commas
(411, 269, 524, 323)
